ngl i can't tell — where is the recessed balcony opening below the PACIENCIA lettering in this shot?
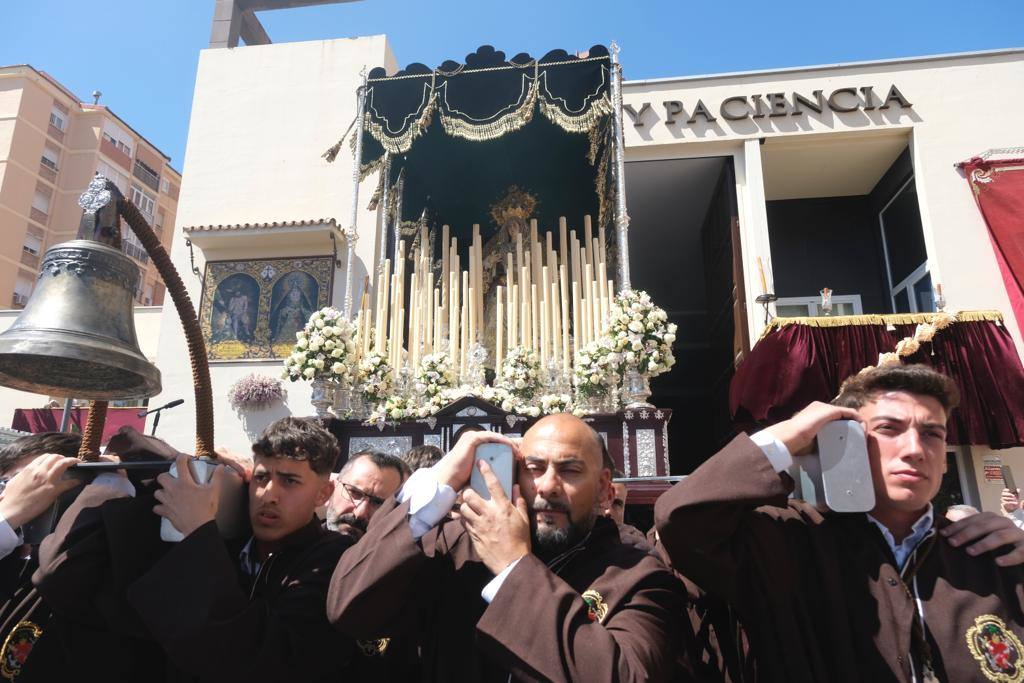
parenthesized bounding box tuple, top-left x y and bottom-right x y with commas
(761, 130, 935, 317)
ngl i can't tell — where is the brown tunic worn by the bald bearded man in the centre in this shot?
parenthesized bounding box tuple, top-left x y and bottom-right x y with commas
(328, 502, 686, 683)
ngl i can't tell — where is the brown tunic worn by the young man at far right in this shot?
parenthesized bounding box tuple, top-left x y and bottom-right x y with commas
(654, 436, 1024, 682)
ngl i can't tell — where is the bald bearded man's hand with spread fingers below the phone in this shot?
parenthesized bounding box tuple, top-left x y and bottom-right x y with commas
(460, 461, 529, 575)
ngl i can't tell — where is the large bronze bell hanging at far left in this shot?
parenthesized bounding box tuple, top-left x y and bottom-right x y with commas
(0, 174, 161, 400)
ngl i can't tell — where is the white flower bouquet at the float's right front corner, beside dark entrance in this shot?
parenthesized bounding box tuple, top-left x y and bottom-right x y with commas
(607, 290, 676, 377)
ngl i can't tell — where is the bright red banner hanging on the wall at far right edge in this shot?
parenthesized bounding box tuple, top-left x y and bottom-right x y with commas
(959, 157, 1024, 330)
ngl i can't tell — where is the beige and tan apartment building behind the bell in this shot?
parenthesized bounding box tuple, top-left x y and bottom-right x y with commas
(0, 65, 181, 308)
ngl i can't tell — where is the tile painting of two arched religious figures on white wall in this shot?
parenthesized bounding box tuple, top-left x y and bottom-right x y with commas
(200, 257, 334, 360)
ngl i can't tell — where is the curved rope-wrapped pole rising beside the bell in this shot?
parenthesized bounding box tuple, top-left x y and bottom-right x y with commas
(116, 200, 216, 458)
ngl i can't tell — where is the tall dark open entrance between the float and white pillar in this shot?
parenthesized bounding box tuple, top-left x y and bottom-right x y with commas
(626, 157, 749, 474)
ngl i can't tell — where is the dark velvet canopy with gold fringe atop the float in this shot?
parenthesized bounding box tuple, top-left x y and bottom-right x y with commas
(325, 45, 614, 255)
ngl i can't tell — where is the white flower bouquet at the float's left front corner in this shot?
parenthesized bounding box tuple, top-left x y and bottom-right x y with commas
(282, 307, 355, 382)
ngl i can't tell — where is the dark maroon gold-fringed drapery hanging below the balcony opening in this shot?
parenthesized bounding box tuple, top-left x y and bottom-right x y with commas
(729, 311, 1024, 447)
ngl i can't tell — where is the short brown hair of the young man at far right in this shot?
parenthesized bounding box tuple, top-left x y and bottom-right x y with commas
(833, 364, 959, 416)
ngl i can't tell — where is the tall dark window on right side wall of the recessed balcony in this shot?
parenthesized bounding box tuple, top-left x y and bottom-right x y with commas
(879, 175, 935, 313)
